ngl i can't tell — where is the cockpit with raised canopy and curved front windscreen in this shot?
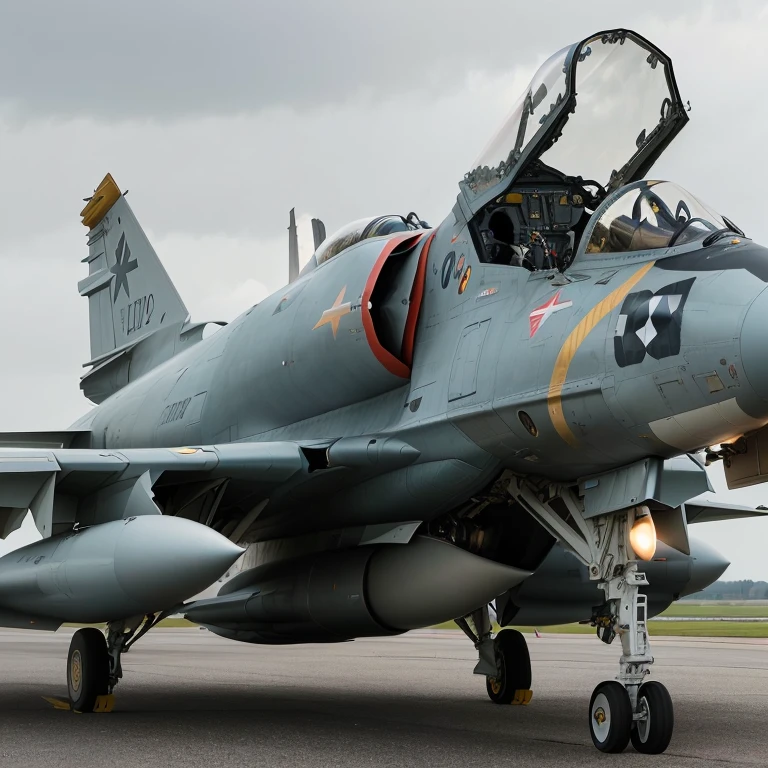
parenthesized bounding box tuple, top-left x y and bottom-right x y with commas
(460, 30, 743, 271)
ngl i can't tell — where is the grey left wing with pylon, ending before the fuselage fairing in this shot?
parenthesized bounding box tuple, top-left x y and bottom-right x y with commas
(0, 442, 309, 538)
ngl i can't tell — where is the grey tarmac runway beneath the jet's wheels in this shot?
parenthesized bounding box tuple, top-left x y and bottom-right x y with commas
(0, 629, 768, 768)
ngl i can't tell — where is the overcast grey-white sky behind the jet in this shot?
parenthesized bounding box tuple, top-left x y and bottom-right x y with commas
(0, 0, 768, 579)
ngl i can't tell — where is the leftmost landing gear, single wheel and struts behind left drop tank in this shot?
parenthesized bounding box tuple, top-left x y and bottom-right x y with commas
(67, 614, 165, 712)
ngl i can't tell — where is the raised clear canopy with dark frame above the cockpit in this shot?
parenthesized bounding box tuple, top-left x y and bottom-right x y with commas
(460, 29, 688, 213)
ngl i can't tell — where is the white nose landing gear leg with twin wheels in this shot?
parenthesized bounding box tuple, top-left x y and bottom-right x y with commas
(508, 477, 675, 754)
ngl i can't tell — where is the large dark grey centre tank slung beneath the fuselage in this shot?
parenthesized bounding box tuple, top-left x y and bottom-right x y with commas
(185, 536, 530, 644)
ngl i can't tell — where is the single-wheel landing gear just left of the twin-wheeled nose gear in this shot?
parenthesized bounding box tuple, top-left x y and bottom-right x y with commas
(456, 606, 533, 704)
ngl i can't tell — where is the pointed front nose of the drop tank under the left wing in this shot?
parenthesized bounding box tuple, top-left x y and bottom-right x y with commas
(115, 515, 244, 611)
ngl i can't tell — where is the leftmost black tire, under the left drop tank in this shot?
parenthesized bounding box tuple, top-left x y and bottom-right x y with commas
(67, 627, 109, 712)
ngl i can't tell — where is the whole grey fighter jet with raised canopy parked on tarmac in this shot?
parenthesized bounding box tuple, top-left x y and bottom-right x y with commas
(0, 29, 768, 753)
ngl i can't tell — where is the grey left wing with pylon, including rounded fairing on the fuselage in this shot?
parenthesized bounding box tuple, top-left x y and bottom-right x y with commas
(0, 433, 420, 541)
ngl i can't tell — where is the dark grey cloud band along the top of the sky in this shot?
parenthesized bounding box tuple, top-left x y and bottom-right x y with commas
(0, 0, 684, 122)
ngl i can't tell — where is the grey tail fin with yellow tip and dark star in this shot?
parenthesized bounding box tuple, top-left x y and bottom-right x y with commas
(78, 174, 189, 362)
